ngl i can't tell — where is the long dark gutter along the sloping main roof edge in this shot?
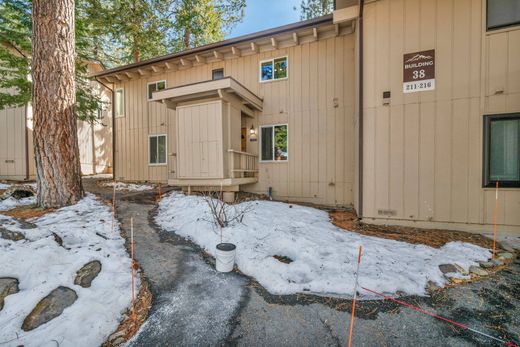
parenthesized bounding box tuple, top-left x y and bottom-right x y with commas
(91, 14, 332, 77)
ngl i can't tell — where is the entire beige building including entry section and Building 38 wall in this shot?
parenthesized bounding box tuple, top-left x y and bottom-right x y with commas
(95, 0, 520, 231)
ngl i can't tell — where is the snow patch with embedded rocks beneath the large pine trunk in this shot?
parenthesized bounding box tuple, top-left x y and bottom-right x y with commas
(0, 194, 131, 346)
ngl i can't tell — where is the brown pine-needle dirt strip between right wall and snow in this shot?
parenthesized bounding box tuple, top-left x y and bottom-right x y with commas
(330, 211, 493, 248)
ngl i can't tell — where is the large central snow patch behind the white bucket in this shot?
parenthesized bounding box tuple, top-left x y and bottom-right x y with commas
(156, 192, 491, 298)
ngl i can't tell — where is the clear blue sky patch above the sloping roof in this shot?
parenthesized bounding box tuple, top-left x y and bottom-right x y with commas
(226, 0, 301, 39)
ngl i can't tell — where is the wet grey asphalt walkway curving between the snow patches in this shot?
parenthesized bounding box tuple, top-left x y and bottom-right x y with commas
(85, 180, 520, 347)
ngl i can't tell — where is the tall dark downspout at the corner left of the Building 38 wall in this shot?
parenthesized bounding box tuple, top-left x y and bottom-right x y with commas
(357, 0, 365, 219)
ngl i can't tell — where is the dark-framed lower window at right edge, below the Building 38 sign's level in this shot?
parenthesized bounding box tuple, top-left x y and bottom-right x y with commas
(484, 113, 520, 187)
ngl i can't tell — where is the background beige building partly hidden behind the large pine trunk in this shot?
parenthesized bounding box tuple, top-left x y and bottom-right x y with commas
(0, 63, 112, 180)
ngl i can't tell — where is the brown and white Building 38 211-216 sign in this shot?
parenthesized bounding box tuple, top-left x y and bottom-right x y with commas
(403, 49, 435, 93)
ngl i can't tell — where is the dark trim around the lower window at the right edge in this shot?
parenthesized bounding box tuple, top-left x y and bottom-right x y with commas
(482, 112, 520, 188)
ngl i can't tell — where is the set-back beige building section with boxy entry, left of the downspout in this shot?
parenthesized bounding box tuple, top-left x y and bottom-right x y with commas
(96, 16, 356, 206)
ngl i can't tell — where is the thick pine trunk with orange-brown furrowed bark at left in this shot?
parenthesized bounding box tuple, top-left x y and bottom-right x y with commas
(32, 0, 83, 208)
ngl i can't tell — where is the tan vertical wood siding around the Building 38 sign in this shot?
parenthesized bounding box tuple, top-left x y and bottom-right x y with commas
(363, 0, 520, 231)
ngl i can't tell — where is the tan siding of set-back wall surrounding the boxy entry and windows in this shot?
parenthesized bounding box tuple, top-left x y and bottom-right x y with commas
(115, 35, 355, 205)
